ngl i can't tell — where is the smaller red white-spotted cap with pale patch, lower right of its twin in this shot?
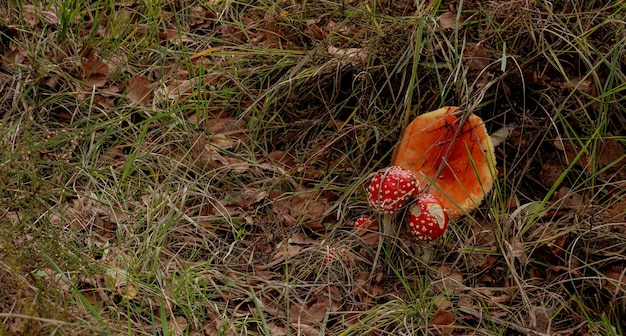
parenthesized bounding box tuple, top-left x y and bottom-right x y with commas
(408, 194, 448, 241)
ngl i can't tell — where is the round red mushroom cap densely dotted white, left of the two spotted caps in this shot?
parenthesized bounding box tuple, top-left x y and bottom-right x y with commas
(367, 166, 418, 213)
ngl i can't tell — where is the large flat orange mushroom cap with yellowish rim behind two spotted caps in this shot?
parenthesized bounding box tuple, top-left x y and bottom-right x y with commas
(391, 106, 496, 217)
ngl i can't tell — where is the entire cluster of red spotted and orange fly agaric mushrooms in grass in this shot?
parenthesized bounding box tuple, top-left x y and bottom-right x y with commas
(355, 106, 497, 241)
